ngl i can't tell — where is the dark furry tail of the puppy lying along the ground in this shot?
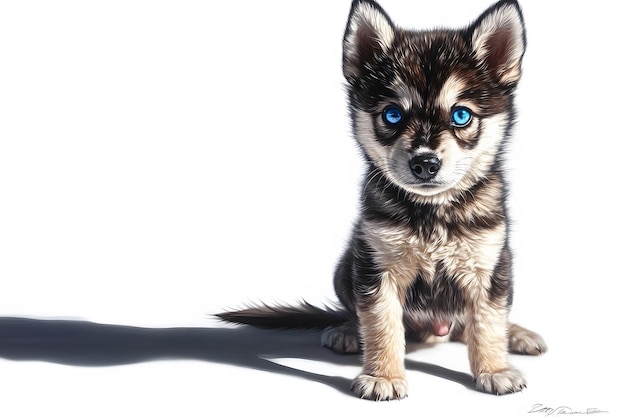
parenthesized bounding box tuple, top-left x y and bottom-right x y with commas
(216, 301, 350, 329)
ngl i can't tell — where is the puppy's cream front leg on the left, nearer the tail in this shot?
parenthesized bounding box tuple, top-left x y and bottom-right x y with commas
(352, 274, 407, 401)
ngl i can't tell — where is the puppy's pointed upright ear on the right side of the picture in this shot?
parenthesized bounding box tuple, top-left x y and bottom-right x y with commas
(470, 0, 526, 84)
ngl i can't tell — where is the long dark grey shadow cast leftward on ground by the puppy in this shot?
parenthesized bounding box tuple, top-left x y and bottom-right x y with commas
(0, 317, 473, 394)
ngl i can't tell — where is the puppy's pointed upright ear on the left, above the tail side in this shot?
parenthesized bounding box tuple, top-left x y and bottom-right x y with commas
(343, 0, 395, 80)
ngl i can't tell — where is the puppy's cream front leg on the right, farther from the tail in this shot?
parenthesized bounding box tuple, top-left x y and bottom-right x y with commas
(466, 294, 526, 395)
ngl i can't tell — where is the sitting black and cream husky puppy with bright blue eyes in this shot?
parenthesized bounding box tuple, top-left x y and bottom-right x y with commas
(218, 0, 546, 400)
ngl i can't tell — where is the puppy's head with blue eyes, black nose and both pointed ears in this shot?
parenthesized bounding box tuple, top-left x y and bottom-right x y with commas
(343, 0, 525, 202)
